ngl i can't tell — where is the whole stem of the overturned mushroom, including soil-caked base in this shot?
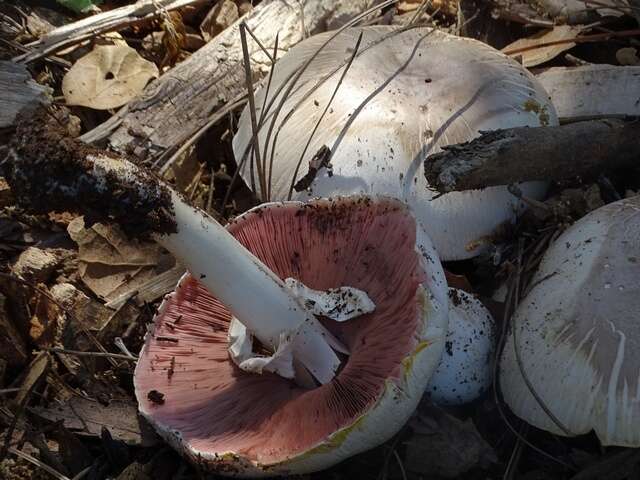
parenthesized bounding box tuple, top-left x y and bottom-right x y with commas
(5, 111, 347, 384)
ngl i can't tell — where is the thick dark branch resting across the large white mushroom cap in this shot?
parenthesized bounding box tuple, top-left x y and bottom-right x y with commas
(424, 119, 640, 193)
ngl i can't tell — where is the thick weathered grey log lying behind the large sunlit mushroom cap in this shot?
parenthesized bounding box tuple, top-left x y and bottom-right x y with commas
(109, 0, 378, 158)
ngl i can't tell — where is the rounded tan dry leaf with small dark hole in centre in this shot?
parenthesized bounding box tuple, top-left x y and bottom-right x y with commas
(62, 45, 158, 110)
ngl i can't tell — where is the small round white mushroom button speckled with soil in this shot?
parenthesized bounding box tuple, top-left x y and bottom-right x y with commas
(426, 288, 495, 405)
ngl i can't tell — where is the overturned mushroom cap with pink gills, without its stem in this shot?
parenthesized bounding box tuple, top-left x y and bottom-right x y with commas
(135, 197, 447, 476)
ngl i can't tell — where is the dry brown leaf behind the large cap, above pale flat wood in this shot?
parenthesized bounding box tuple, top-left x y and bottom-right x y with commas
(502, 25, 584, 67)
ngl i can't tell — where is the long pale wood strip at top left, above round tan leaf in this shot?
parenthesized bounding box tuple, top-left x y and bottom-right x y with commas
(14, 0, 204, 63)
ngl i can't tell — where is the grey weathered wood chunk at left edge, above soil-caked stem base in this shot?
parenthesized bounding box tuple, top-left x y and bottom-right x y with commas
(0, 61, 51, 128)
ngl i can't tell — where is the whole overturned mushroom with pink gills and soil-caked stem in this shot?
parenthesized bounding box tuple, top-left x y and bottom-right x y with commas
(0, 111, 448, 475)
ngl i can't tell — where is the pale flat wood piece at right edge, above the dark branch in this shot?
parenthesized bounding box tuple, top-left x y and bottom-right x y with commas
(537, 65, 640, 121)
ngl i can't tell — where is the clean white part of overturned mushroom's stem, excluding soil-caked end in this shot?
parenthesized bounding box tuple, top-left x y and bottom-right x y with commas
(155, 192, 344, 384)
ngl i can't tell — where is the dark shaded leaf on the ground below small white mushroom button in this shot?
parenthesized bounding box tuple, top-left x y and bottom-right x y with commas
(405, 405, 498, 478)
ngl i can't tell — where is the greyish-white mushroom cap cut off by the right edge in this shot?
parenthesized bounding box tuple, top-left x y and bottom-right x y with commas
(500, 197, 640, 447)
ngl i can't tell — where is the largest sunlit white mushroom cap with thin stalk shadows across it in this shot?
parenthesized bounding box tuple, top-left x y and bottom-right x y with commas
(233, 26, 558, 260)
